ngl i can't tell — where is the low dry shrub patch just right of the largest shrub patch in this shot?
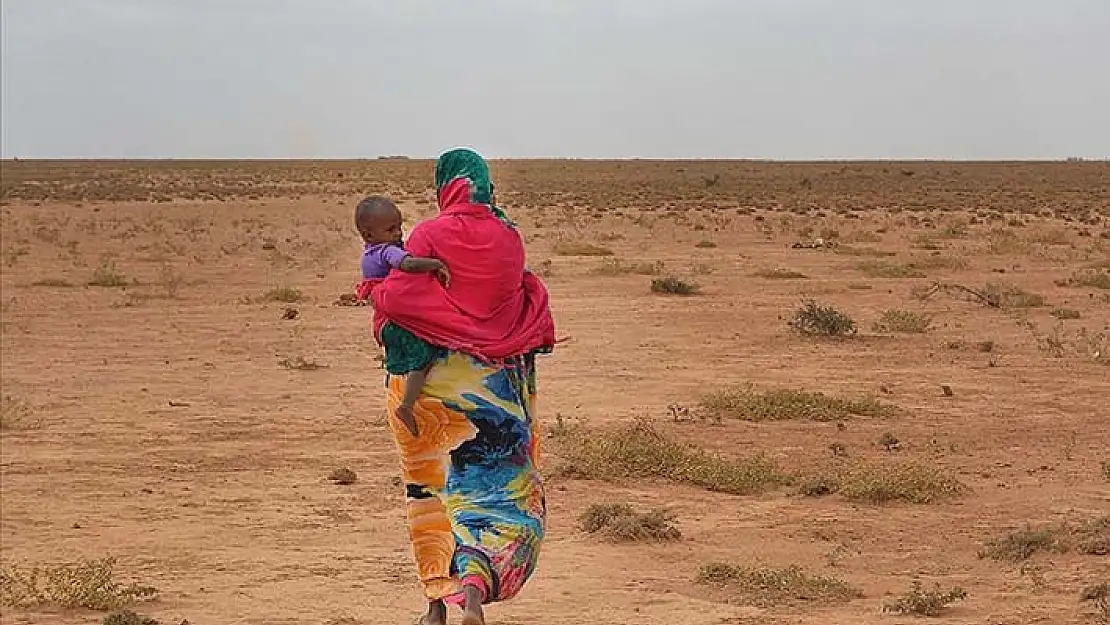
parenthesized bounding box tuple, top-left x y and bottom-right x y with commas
(834, 463, 966, 504)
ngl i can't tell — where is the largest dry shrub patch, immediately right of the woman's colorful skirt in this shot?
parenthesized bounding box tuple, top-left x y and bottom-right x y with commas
(556, 422, 790, 495)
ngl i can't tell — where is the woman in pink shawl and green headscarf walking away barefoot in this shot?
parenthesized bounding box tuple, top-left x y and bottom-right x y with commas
(371, 149, 555, 625)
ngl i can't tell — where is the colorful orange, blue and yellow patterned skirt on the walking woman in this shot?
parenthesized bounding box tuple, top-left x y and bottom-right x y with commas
(386, 352, 547, 603)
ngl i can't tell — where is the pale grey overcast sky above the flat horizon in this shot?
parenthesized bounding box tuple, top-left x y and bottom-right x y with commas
(0, 0, 1110, 159)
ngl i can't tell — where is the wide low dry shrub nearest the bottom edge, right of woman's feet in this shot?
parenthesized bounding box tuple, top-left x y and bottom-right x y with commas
(697, 563, 864, 607)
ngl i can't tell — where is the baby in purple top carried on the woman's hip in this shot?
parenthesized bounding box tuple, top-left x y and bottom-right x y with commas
(354, 195, 451, 436)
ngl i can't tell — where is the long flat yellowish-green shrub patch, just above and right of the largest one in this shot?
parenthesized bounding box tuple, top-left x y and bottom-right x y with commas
(700, 387, 895, 422)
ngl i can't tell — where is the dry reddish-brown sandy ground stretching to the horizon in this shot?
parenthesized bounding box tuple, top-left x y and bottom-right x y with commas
(0, 160, 1110, 625)
